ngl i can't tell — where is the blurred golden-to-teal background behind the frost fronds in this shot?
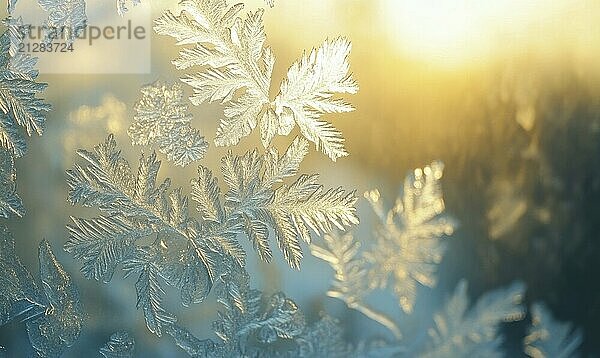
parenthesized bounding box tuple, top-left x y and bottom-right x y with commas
(0, 0, 600, 357)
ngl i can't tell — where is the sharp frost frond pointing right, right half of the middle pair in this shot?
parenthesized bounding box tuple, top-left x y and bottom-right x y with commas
(192, 138, 358, 268)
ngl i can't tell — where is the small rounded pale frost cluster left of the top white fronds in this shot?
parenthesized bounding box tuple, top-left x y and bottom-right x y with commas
(127, 82, 208, 166)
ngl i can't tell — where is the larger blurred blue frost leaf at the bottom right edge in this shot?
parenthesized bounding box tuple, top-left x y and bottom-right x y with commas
(421, 280, 525, 358)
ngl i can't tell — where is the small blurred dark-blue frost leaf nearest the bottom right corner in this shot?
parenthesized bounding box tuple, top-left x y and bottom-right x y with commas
(524, 303, 583, 358)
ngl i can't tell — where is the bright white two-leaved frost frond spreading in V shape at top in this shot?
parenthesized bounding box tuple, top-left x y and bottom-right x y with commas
(154, 0, 358, 160)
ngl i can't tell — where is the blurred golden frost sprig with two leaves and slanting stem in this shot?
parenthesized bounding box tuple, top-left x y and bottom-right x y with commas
(311, 162, 455, 328)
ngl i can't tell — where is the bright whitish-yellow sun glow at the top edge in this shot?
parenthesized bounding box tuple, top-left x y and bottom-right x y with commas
(380, 0, 586, 66)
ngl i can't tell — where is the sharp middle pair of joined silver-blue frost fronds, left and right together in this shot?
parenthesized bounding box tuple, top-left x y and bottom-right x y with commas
(65, 136, 358, 336)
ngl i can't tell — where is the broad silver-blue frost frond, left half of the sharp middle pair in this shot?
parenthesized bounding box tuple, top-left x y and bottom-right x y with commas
(65, 135, 216, 335)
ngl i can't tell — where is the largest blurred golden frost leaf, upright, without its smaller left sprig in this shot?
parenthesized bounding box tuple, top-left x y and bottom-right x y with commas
(365, 162, 455, 312)
